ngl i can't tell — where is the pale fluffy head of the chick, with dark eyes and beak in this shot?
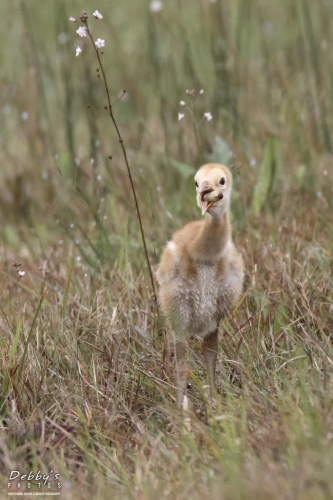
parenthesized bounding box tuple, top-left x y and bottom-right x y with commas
(194, 163, 232, 218)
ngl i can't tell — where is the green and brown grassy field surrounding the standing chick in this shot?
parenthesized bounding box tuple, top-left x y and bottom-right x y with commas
(0, 0, 333, 500)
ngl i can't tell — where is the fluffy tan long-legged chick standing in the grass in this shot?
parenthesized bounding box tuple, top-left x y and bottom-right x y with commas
(156, 163, 244, 408)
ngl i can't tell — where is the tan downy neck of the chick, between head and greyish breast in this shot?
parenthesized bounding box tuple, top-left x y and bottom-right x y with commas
(189, 210, 231, 262)
